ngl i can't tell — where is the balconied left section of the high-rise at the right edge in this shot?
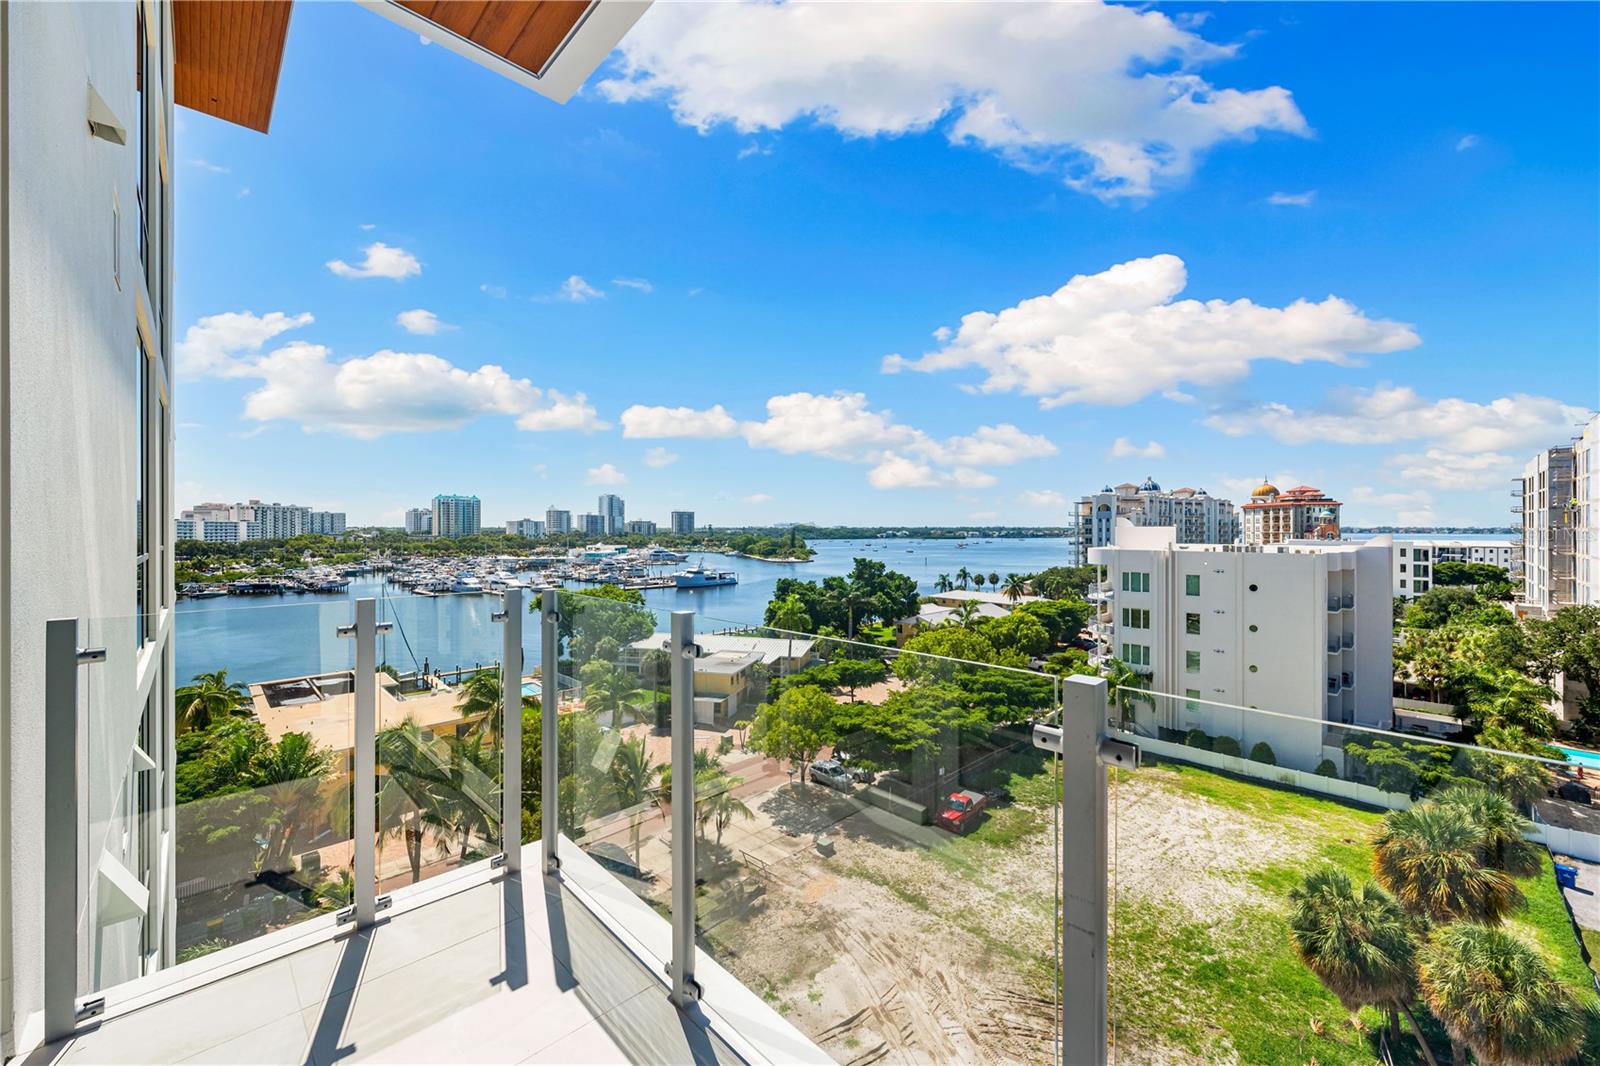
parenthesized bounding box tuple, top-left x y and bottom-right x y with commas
(1512, 445, 1582, 618)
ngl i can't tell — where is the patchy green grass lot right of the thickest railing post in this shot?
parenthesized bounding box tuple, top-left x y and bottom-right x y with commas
(1110, 762, 1600, 1066)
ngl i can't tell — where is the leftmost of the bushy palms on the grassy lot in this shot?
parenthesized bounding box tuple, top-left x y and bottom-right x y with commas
(1290, 866, 1434, 1064)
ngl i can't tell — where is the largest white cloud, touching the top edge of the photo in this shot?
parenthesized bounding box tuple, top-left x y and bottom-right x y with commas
(598, 3, 1310, 200)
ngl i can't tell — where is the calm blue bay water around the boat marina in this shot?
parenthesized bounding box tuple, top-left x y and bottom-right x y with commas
(173, 538, 1069, 682)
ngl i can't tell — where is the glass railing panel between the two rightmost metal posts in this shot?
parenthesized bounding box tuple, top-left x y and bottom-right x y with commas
(694, 618, 1061, 1063)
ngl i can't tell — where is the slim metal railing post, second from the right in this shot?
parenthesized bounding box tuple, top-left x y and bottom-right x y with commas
(667, 611, 699, 1007)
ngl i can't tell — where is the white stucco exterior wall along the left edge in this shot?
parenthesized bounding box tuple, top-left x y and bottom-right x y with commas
(0, 3, 171, 1050)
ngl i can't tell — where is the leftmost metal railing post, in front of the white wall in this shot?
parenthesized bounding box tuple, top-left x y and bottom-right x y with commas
(45, 618, 106, 1042)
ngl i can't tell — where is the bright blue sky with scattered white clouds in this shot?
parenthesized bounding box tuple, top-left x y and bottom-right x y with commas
(176, 3, 1600, 525)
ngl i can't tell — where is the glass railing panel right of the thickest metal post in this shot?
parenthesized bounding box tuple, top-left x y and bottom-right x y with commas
(1109, 691, 1600, 1063)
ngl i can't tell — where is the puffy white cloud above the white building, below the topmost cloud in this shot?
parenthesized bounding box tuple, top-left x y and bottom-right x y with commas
(883, 254, 1421, 408)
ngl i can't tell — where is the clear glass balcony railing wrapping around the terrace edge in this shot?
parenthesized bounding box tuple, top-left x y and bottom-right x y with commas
(46, 591, 1600, 1063)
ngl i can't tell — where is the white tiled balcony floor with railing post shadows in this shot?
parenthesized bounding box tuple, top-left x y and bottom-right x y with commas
(27, 855, 744, 1066)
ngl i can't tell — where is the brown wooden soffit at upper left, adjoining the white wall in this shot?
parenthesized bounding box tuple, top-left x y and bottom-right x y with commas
(173, 0, 293, 133)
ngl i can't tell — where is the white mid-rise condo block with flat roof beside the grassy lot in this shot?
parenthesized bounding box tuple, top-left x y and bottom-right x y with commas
(1090, 522, 1394, 770)
